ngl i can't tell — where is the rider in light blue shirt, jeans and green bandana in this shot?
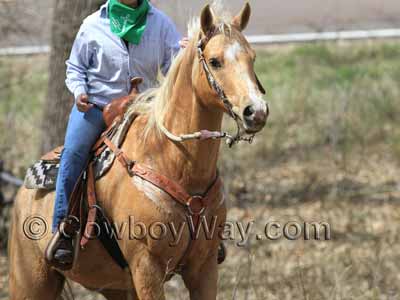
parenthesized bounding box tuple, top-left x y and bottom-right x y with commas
(52, 0, 187, 265)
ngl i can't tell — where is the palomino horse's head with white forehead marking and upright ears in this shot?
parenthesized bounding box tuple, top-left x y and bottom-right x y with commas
(194, 3, 269, 134)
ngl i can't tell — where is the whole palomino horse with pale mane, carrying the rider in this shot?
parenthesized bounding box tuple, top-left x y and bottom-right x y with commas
(9, 4, 268, 300)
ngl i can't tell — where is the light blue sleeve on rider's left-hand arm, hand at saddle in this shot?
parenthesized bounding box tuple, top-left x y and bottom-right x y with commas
(65, 27, 91, 99)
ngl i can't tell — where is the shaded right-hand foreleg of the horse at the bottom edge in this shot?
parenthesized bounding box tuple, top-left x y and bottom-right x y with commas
(183, 256, 218, 300)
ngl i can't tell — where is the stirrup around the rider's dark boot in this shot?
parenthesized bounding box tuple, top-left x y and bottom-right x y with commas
(45, 217, 80, 271)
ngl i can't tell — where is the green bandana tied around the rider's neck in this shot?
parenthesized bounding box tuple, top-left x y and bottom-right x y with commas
(108, 0, 150, 45)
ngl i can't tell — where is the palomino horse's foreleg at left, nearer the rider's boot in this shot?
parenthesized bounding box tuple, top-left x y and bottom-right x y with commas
(130, 250, 166, 300)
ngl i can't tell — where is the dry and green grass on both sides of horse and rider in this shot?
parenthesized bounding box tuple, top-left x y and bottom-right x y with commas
(0, 41, 400, 299)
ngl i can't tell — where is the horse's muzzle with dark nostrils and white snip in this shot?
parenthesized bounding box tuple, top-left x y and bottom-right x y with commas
(243, 101, 269, 134)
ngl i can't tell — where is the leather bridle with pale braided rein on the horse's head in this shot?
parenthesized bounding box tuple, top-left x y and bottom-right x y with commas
(160, 29, 265, 148)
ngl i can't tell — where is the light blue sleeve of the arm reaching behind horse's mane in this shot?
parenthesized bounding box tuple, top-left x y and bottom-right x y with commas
(161, 19, 181, 75)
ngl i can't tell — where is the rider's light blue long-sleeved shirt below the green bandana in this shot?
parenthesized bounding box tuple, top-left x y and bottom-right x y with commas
(65, 3, 181, 106)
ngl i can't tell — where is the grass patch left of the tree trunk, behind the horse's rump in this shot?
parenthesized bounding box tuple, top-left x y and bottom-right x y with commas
(0, 56, 48, 176)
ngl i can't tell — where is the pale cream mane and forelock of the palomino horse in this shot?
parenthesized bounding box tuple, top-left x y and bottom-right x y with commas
(127, 0, 232, 137)
